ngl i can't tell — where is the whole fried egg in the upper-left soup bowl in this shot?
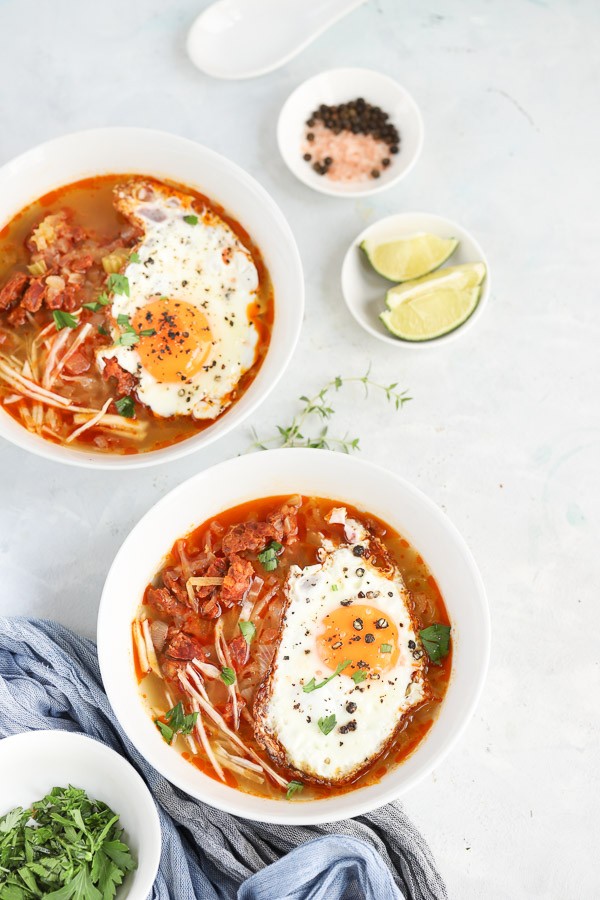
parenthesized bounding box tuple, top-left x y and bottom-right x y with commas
(97, 179, 259, 419)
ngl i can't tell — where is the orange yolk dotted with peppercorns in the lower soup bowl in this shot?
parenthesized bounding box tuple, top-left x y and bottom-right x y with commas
(317, 603, 400, 677)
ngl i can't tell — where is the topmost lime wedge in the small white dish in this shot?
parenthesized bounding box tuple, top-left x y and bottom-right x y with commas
(360, 234, 458, 281)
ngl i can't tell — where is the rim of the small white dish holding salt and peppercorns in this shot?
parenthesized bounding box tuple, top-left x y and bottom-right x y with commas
(277, 66, 425, 199)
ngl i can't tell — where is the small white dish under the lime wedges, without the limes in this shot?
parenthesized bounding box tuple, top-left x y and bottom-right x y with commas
(342, 213, 491, 350)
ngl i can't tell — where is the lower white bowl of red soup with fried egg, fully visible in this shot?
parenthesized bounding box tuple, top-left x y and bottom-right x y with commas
(98, 449, 490, 823)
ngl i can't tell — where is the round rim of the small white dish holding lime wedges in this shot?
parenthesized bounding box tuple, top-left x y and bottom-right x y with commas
(340, 211, 492, 351)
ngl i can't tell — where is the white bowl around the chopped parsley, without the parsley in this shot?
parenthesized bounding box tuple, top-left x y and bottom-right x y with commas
(0, 730, 161, 900)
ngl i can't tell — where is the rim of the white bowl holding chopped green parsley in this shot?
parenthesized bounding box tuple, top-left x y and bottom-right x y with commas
(0, 728, 162, 900)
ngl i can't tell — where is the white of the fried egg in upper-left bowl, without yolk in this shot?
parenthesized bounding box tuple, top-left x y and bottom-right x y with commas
(97, 182, 258, 419)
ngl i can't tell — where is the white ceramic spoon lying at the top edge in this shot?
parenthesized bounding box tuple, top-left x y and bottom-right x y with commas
(187, 0, 366, 78)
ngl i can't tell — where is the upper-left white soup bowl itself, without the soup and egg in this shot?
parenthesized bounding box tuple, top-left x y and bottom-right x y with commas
(0, 128, 304, 469)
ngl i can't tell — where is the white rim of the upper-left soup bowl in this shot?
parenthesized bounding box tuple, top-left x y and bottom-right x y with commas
(0, 125, 305, 471)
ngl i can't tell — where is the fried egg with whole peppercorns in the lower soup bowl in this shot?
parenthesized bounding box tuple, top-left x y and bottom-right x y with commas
(254, 510, 431, 784)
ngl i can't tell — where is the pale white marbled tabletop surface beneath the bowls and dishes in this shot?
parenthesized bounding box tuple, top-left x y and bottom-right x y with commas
(0, 0, 600, 900)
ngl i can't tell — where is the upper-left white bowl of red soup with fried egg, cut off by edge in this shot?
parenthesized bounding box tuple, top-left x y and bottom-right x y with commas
(0, 128, 304, 468)
